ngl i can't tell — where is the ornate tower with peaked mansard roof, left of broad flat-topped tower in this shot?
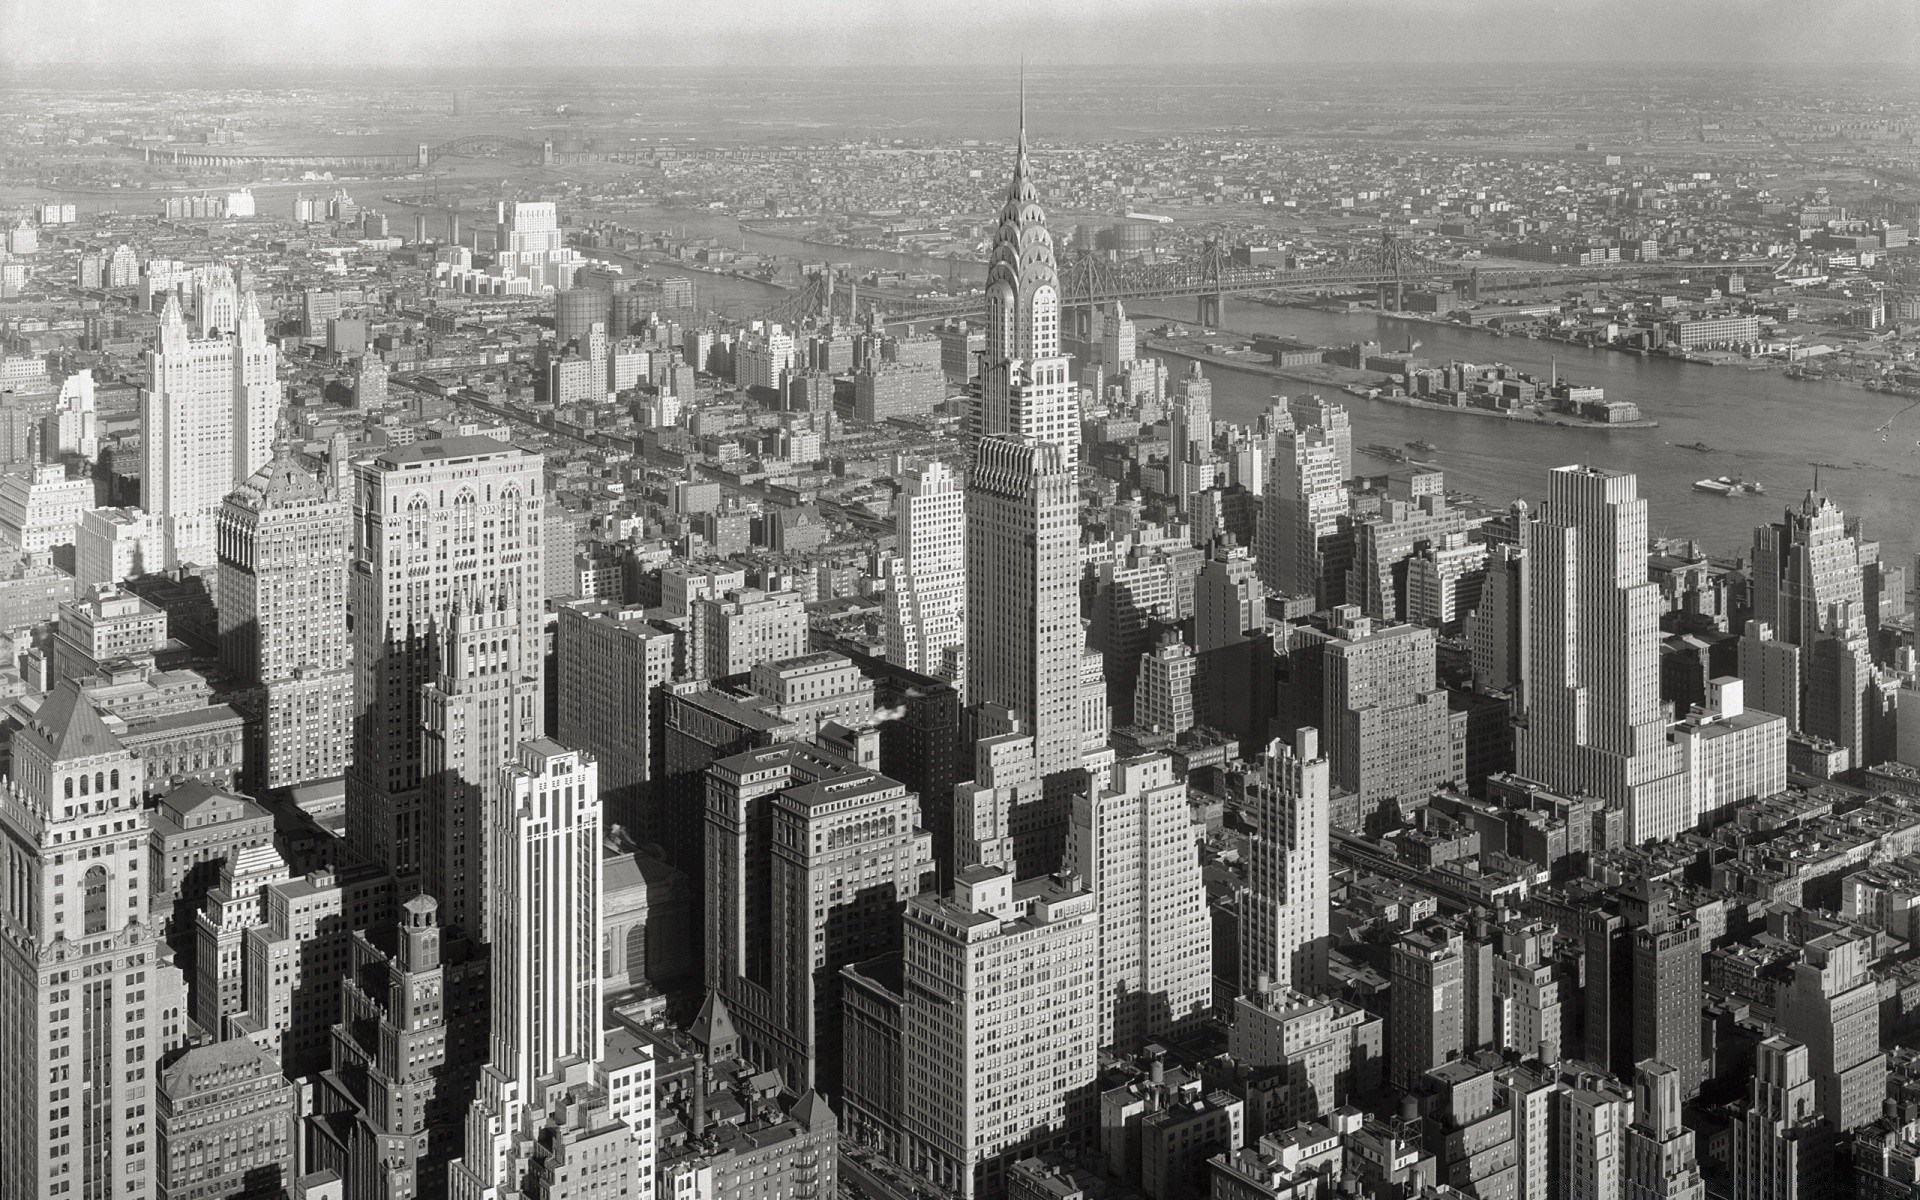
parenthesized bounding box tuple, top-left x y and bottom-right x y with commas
(215, 437, 353, 787)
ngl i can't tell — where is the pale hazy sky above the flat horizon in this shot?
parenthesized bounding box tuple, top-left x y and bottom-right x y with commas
(0, 0, 1920, 68)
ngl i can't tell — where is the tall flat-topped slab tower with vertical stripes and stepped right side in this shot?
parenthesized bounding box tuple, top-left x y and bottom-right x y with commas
(1517, 467, 1692, 840)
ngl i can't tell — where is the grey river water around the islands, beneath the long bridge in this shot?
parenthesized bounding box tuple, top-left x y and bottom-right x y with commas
(591, 209, 1920, 564)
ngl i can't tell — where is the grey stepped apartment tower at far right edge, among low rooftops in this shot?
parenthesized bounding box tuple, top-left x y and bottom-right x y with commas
(1778, 927, 1887, 1133)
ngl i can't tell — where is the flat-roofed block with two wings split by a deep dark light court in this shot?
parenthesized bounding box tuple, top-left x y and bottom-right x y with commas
(705, 735, 933, 1092)
